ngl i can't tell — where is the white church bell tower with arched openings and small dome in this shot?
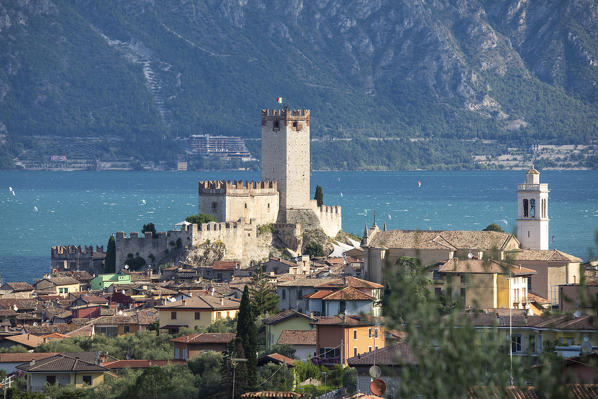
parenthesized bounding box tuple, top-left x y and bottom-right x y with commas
(517, 166, 549, 249)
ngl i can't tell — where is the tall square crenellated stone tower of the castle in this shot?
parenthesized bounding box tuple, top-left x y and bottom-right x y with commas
(262, 107, 315, 223)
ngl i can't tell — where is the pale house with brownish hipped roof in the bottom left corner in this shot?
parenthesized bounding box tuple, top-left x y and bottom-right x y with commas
(17, 352, 111, 392)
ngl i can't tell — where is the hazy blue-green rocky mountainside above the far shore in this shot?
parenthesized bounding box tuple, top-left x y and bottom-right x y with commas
(0, 0, 598, 150)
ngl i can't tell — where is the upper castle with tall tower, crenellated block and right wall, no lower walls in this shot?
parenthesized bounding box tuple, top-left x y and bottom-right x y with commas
(198, 108, 342, 237)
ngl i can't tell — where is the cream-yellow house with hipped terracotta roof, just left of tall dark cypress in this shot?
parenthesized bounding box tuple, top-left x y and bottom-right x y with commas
(156, 295, 240, 334)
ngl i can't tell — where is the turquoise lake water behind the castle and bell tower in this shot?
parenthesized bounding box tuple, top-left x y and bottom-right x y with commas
(0, 171, 598, 281)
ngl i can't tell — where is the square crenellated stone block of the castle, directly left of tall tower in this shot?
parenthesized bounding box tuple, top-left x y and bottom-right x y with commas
(198, 180, 279, 224)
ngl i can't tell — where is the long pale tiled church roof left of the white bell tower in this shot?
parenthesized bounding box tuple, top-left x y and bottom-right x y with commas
(368, 230, 518, 250)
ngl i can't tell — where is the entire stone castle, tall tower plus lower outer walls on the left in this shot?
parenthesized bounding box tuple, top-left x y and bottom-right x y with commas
(116, 108, 342, 269)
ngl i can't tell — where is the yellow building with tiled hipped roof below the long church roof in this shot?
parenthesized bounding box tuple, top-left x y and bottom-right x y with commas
(433, 258, 536, 309)
